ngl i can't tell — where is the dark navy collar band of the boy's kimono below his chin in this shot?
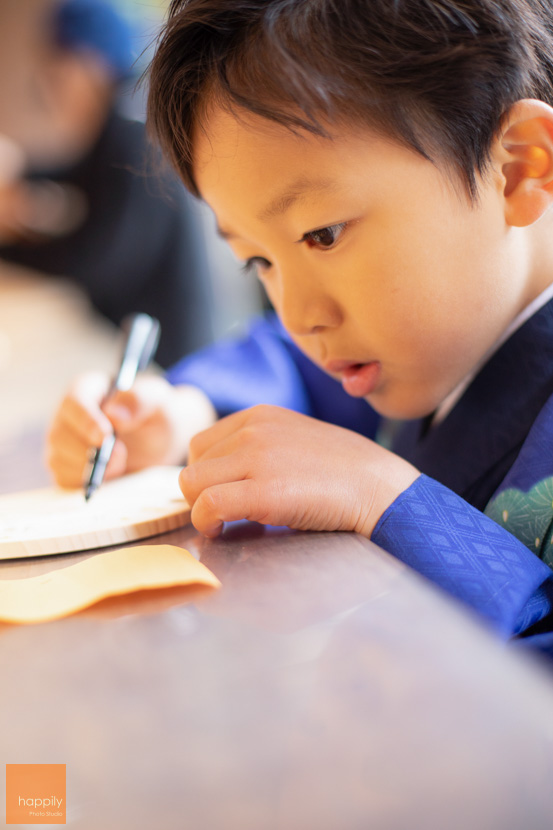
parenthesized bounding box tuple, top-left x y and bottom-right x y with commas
(393, 292, 553, 510)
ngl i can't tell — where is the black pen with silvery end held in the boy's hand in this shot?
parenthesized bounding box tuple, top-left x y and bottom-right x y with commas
(84, 314, 160, 501)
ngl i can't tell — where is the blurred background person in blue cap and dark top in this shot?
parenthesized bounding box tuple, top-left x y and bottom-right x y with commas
(0, 0, 220, 367)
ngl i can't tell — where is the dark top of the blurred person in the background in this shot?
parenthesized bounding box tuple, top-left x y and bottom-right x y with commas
(0, 113, 218, 367)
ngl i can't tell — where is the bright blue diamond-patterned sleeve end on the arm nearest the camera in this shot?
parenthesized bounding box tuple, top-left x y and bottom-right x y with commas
(372, 475, 553, 639)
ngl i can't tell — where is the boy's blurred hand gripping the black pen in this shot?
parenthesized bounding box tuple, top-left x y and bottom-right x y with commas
(47, 373, 216, 487)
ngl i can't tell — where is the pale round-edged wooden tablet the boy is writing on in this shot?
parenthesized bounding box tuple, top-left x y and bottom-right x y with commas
(0, 467, 190, 559)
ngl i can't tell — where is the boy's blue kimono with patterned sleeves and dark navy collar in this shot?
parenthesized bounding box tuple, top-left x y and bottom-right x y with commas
(168, 300, 553, 656)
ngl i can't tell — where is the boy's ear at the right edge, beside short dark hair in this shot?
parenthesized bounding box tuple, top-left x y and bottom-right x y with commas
(492, 99, 553, 227)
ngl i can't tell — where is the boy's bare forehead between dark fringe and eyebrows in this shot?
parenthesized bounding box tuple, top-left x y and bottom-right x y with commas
(192, 105, 428, 210)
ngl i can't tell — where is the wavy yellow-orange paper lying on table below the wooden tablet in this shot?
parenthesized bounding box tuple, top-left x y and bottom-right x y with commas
(0, 545, 221, 623)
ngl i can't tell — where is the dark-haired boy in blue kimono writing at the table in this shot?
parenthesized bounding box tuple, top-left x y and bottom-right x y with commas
(46, 0, 553, 643)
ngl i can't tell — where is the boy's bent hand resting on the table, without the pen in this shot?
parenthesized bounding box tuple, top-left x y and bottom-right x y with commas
(180, 406, 419, 536)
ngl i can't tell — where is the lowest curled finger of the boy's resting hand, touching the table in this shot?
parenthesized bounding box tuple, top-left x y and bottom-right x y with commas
(190, 479, 267, 538)
